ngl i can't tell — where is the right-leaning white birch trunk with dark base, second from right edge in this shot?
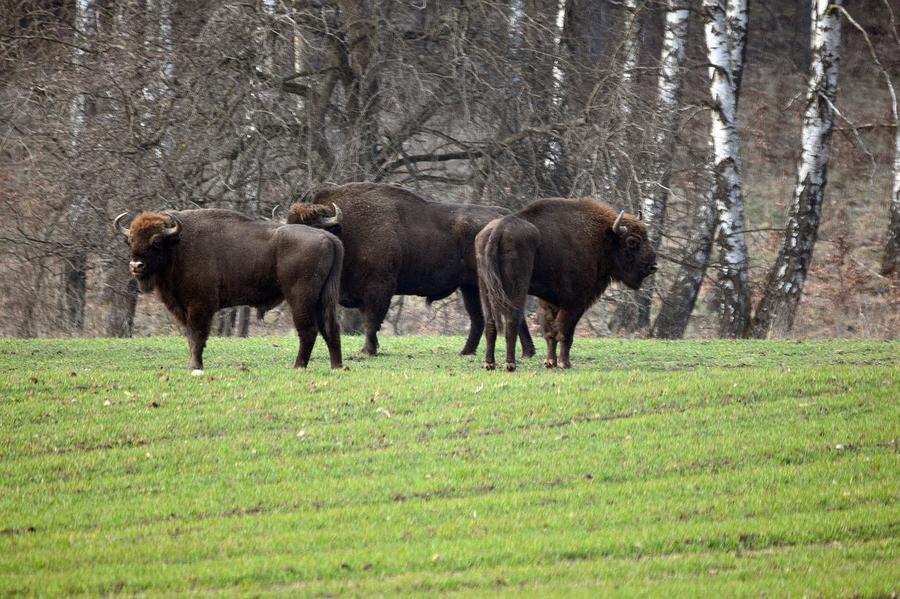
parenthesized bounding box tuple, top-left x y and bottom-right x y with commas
(752, 0, 841, 338)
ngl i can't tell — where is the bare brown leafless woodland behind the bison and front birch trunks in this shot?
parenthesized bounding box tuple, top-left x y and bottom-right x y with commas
(0, 0, 900, 338)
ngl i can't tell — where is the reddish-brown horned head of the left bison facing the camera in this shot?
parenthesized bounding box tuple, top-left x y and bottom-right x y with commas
(113, 212, 181, 293)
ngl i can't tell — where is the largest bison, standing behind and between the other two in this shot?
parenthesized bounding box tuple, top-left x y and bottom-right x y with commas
(287, 183, 534, 356)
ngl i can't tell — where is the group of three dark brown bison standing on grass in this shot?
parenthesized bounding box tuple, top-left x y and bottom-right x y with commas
(114, 183, 656, 373)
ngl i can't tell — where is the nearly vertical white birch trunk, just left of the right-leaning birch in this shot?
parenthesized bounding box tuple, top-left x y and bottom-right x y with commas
(703, 0, 750, 337)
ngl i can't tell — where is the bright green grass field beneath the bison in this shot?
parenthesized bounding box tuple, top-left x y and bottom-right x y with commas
(0, 337, 900, 597)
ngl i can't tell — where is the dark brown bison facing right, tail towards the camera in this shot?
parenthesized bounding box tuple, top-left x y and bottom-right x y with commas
(475, 198, 656, 371)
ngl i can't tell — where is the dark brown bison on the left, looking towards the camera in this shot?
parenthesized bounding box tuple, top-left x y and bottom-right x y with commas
(114, 210, 344, 373)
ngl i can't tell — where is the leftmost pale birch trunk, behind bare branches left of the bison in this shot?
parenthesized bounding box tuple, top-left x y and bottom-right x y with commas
(62, 0, 97, 333)
